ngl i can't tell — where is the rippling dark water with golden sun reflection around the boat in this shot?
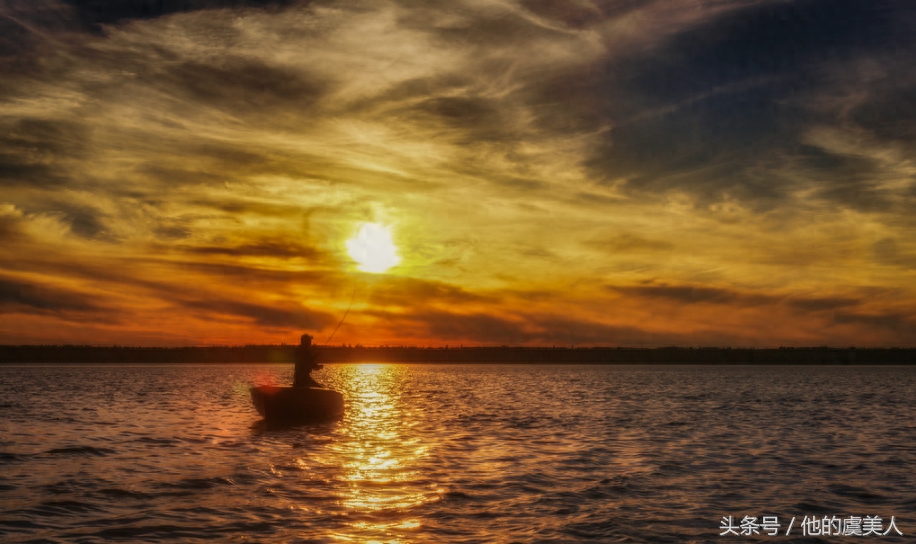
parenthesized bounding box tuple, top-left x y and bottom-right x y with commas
(0, 365, 916, 542)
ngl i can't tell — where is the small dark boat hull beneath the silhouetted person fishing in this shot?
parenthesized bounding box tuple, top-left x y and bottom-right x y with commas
(251, 385, 344, 424)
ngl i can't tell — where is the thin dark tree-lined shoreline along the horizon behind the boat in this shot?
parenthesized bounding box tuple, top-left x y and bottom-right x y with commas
(0, 345, 916, 365)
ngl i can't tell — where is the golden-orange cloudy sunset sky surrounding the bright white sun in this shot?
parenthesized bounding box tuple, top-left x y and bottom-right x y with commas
(0, 0, 916, 347)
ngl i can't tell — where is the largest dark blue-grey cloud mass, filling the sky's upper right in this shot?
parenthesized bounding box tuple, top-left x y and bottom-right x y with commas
(572, 0, 916, 209)
